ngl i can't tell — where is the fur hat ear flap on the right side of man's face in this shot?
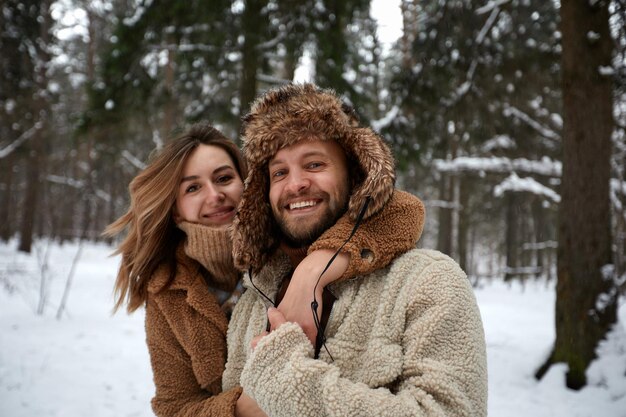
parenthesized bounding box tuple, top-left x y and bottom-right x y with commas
(346, 128, 396, 220)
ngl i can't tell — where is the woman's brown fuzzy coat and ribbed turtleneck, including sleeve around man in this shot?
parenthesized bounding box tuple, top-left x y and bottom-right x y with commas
(146, 192, 424, 417)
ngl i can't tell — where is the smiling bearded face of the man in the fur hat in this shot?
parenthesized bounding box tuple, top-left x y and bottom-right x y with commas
(268, 140, 350, 247)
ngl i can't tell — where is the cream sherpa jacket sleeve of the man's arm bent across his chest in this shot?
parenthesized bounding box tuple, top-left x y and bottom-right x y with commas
(236, 262, 487, 417)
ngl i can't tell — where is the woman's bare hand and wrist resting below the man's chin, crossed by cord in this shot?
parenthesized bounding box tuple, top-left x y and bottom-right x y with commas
(276, 249, 350, 345)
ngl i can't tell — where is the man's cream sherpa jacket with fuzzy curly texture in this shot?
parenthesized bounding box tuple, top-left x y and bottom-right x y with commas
(222, 249, 487, 417)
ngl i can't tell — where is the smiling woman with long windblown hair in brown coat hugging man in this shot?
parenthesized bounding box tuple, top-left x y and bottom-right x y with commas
(105, 124, 423, 416)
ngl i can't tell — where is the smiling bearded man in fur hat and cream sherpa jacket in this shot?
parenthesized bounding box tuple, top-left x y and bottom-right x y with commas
(223, 84, 487, 417)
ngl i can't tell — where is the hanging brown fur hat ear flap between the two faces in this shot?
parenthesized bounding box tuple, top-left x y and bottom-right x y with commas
(233, 169, 276, 270)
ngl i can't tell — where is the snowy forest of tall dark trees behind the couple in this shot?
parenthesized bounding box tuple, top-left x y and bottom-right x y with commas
(0, 0, 626, 412)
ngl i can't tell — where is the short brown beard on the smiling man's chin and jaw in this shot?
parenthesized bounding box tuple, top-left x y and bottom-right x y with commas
(274, 193, 349, 248)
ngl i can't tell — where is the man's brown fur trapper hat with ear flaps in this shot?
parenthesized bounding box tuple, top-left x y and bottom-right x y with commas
(233, 84, 395, 270)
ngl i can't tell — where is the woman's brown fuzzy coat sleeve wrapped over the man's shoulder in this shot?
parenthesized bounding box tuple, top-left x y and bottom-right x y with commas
(308, 190, 425, 280)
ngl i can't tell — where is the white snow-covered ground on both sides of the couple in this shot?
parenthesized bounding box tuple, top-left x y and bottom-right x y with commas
(0, 242, 626, 417)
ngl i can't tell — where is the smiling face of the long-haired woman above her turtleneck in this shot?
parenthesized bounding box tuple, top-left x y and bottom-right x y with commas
(174, 145, 243, 227)
